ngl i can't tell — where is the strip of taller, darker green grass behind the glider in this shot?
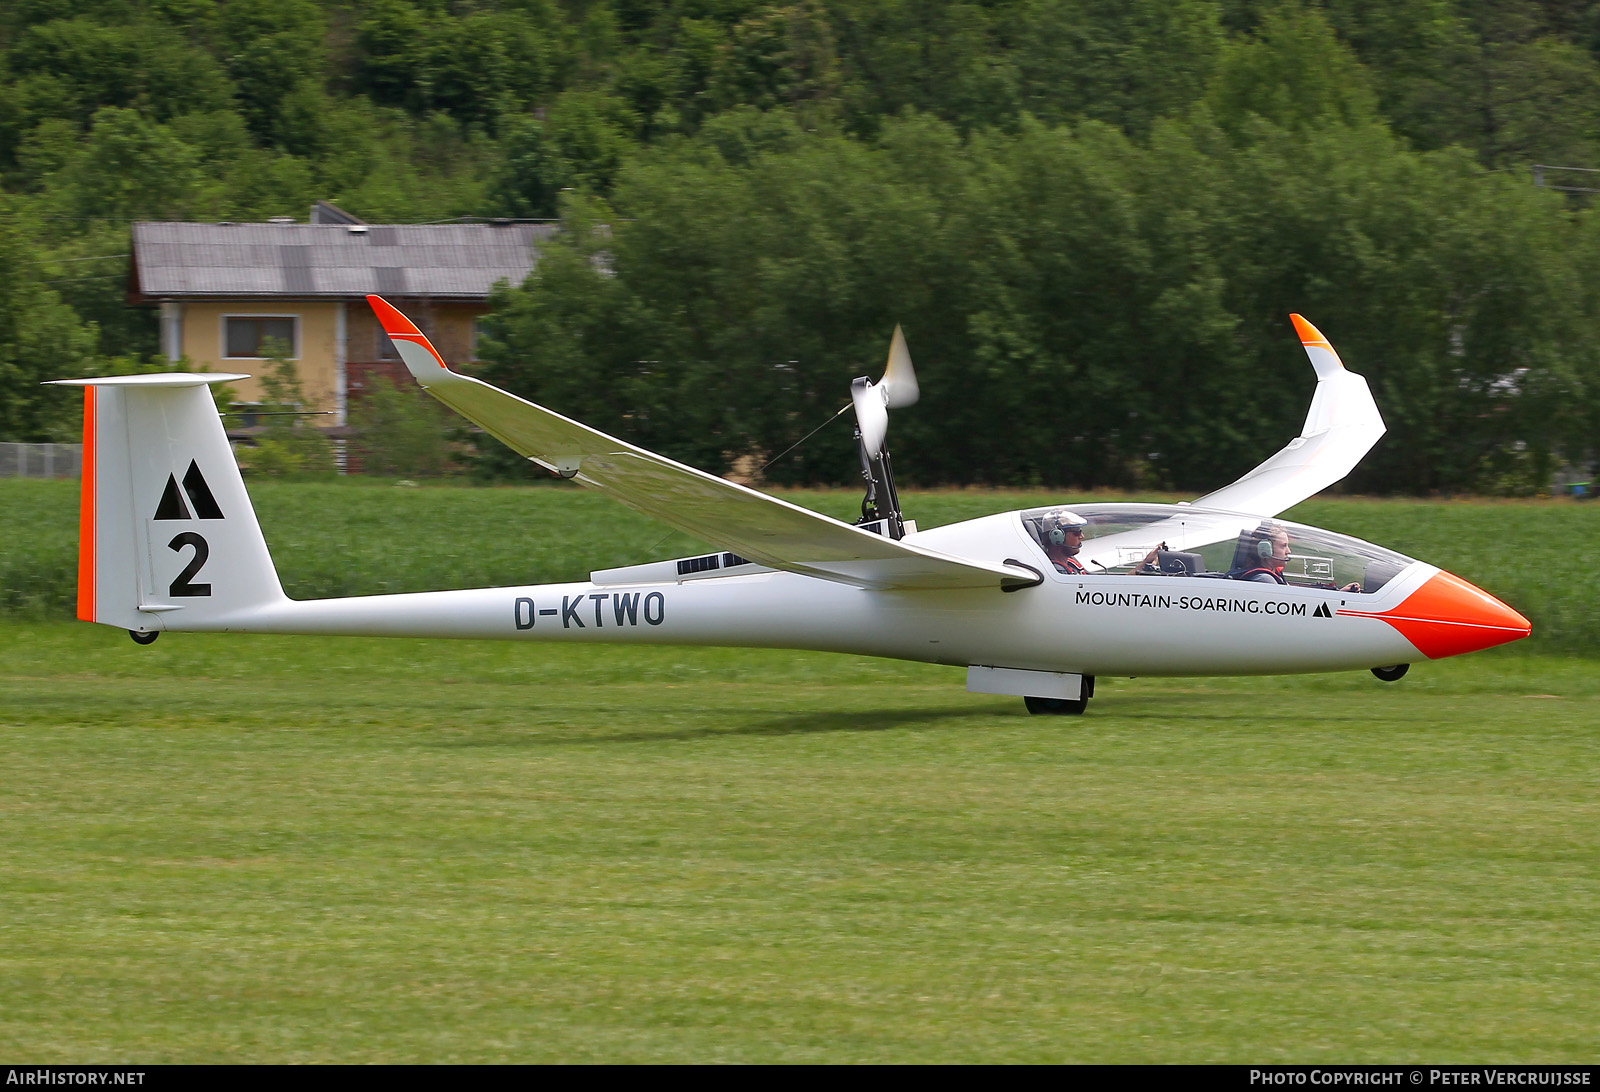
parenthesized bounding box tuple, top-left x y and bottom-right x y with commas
(0, 480, 1600, 652)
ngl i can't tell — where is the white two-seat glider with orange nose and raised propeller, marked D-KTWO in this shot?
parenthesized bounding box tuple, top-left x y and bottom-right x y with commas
(50, 296, 1530, 714)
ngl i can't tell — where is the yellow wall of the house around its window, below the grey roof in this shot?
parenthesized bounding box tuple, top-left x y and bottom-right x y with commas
(179, 299, 344, 412)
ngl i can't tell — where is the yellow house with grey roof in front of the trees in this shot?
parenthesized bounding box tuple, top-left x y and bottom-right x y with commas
(128, 202, 555, 426)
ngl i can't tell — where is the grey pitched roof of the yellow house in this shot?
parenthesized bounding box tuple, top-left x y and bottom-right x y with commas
(131, 223, 555, 299)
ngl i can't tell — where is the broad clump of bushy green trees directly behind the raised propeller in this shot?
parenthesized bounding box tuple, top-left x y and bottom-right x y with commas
(485, 104, 1595, 492)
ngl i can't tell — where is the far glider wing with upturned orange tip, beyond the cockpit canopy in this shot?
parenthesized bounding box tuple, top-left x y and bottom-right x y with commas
(1194, 315, 1384, 516)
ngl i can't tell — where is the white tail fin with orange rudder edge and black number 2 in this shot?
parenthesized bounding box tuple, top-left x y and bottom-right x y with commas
(46, 373, 283, 632)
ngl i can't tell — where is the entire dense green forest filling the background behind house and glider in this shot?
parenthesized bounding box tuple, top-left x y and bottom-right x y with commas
(0, 0, 1600, 493)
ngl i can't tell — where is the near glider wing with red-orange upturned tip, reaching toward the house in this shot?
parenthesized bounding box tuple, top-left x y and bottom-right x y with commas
(366, 296, 1038, 588)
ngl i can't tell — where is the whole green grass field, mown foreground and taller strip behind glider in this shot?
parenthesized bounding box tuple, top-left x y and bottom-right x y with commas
(0, 484, 1600, 1062)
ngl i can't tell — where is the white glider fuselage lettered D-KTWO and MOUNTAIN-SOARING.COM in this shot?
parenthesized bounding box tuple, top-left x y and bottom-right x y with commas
(175, 512, 1438, 676)
